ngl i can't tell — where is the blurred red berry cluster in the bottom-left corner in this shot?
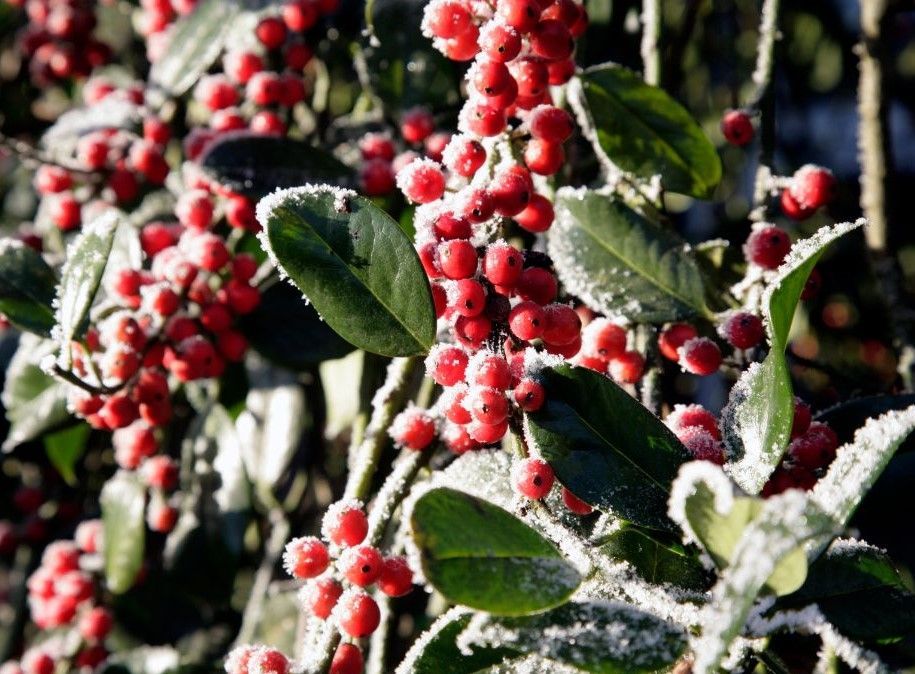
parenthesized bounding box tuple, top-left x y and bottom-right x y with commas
(0, 520, 114, 674)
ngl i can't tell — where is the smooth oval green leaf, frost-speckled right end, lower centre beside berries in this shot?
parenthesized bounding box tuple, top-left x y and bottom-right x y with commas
(410, 488, 581, 616)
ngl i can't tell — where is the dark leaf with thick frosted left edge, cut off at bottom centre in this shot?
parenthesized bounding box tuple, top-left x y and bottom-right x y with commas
(396, 607, 516, 674)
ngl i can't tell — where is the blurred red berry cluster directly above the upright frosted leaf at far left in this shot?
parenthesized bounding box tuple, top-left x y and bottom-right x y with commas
(34, 103, 171, 232)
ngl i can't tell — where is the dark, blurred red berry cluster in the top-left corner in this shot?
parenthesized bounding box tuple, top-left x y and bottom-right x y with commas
(10, 0, 111, 87)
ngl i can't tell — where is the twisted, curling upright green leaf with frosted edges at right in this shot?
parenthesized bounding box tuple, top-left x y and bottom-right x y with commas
(722, 220, 864, 494)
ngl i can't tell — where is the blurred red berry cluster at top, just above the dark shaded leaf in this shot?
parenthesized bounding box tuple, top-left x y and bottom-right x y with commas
(182, 0, 338, 144)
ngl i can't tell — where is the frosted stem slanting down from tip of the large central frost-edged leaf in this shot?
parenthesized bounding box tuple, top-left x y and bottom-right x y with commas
(344, 357, 422, 500)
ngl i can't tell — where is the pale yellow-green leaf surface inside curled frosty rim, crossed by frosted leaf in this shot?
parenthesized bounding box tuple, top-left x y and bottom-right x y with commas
(685, 484, 807, 595)
